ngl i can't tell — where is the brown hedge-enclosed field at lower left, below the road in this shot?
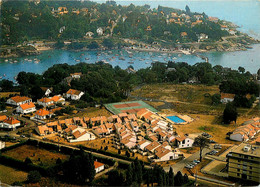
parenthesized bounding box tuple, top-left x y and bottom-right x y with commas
(2, 145, 69, 167)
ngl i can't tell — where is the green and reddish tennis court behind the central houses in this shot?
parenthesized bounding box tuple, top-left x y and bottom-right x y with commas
(105, 101, 157, 114)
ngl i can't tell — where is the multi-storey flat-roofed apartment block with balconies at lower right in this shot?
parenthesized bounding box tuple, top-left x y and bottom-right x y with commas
(227, 143, 260, 183)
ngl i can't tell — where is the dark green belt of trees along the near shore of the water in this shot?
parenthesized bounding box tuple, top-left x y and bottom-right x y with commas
(0, 61, 259, 107)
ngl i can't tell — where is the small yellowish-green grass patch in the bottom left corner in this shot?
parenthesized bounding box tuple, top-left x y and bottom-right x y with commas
(0, 165, 28, 184)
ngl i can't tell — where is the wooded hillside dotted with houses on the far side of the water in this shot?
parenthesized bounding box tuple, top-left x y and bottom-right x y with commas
(1, 1, 228, 45)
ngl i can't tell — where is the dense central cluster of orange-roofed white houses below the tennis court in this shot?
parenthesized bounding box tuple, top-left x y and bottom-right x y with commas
(36, 109, 197, 161)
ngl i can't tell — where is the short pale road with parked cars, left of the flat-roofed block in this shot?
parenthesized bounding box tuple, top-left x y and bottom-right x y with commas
(163, 146, 213, 173)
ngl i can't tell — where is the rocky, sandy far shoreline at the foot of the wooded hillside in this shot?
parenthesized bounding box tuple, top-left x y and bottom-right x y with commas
(0, 35, 260, 58)
